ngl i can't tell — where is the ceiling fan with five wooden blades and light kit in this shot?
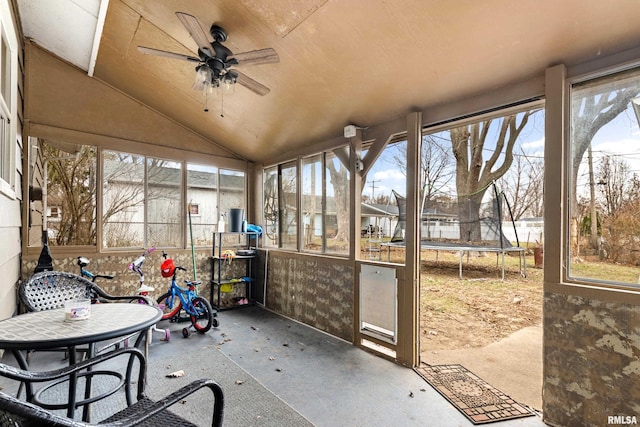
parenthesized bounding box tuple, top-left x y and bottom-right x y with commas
(138, 12, 280, 96)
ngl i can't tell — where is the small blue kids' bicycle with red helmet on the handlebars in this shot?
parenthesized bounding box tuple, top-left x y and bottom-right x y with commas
(157, 251, 218, 338)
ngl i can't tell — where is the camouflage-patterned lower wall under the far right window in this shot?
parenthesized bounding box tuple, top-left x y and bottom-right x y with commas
(543, 293, 640, 427)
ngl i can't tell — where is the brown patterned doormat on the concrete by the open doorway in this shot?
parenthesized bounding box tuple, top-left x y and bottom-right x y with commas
(415, 365, 535, 424)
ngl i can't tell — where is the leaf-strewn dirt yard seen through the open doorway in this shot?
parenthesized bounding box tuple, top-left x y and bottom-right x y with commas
(420, 251, 543, 355)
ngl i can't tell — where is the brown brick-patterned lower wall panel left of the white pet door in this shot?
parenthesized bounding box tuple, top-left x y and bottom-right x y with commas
(265, 251, 355, 342)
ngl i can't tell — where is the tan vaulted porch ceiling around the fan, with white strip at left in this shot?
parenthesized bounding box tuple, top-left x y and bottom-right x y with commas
(17, 0, 640, 161)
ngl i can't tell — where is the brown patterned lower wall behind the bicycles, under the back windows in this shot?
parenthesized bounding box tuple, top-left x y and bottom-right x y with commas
(22, 249, 211, 299)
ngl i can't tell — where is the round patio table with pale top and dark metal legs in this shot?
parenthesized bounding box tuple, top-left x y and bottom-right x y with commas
(0, 303, 162, 421)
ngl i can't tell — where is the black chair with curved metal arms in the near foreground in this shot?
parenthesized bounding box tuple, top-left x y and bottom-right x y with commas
(0, 348, 224, 427)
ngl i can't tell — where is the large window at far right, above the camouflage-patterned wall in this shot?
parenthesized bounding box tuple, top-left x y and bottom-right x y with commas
(566, 69, 640, 287)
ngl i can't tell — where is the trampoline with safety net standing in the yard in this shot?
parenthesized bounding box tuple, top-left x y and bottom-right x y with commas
(381, 183, 527, 280)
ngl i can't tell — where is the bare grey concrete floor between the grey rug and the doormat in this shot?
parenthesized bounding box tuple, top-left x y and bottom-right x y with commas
(204, 307, 545, 427)
